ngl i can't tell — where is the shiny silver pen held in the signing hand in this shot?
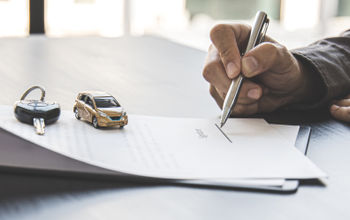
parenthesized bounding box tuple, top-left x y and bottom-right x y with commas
(220, 11, 269, 127)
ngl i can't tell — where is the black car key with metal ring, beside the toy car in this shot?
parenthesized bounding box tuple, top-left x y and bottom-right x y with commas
(15, 86, 61, 135)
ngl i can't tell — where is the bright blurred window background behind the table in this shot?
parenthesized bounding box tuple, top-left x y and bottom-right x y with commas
(0, 0, 350, 50)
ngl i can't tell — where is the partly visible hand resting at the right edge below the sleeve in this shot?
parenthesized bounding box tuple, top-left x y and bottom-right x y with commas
(329, 95, 350, 122)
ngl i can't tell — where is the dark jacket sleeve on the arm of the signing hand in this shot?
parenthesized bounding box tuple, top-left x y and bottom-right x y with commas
(292, 30, 350, 109)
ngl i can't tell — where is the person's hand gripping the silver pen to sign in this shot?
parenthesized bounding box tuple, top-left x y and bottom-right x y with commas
(203, 24, 313, 115)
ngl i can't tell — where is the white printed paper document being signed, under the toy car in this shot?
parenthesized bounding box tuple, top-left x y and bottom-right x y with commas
(0, 106, 326, 180)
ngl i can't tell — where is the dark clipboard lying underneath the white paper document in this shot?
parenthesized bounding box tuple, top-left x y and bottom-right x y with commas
(0, 126, 311, 193)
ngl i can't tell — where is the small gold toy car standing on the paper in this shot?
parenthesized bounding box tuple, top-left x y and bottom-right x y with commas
(73, 91, 128, 128)
